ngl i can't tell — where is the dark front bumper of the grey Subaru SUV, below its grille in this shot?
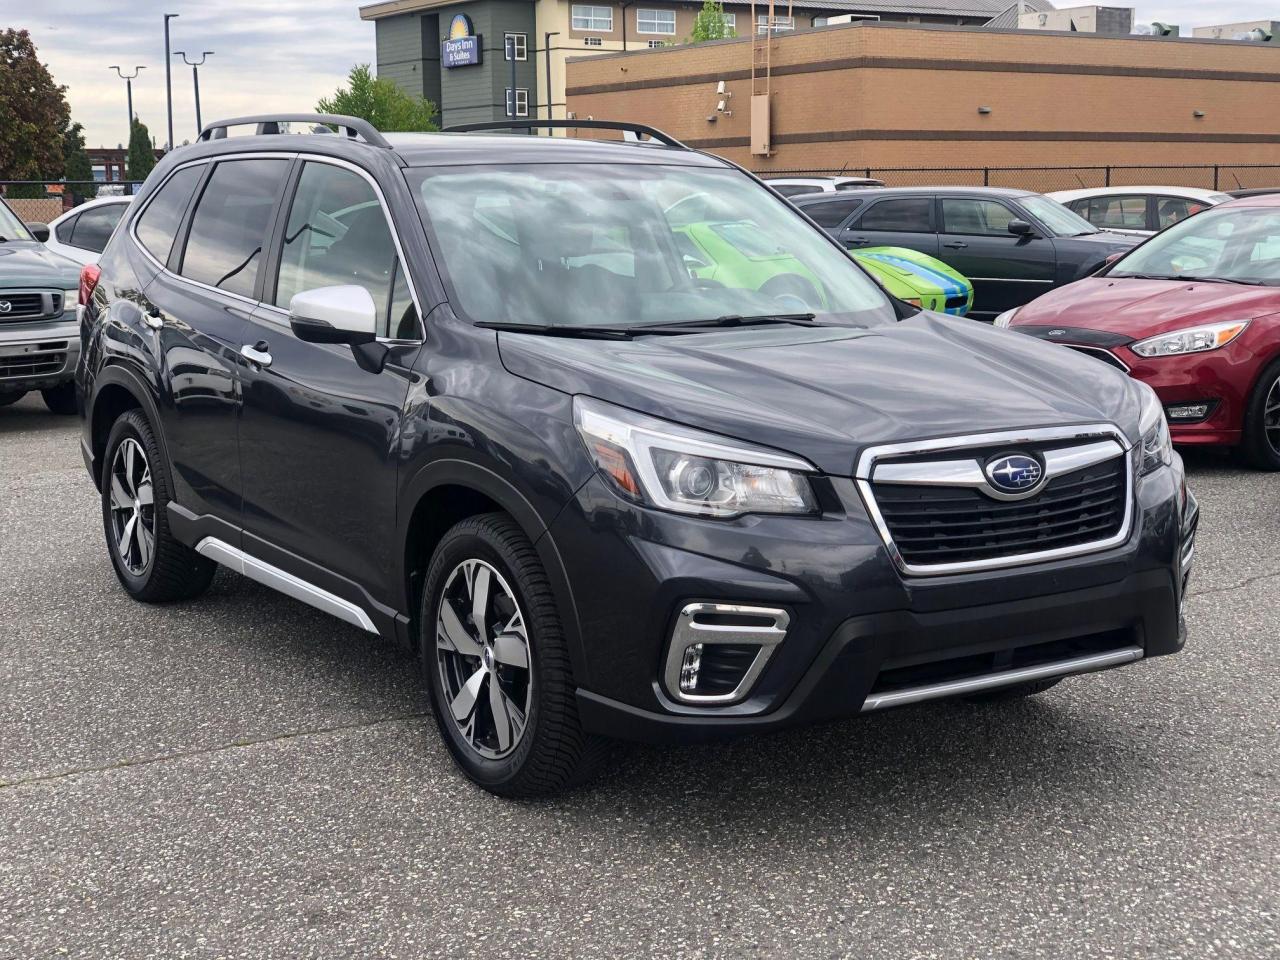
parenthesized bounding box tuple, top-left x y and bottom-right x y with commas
(550, 461, 1196, 741)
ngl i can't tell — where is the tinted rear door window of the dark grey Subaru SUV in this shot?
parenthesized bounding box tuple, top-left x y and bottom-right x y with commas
(182, 160, 289, 297)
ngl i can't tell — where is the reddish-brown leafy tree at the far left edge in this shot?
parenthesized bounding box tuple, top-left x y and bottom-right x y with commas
(0, 28, 70, 196)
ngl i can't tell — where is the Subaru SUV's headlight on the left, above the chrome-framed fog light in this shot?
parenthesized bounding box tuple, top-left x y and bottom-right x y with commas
(573, 397, 817, 517)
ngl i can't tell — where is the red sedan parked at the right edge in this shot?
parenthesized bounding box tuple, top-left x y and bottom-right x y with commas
(996, 195, 1280, 470)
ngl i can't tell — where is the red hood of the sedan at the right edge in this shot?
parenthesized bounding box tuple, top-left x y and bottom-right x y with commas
(1012, 276, 1280, 342)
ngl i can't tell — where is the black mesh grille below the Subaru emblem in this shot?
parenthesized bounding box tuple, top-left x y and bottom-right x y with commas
(872, 456, 1128, 566)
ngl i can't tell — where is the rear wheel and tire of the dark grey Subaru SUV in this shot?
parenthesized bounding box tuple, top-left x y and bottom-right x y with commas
(102, 410, 218, 603)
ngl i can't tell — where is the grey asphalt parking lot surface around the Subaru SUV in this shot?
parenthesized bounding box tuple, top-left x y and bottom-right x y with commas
(0, 397, 1280, 960)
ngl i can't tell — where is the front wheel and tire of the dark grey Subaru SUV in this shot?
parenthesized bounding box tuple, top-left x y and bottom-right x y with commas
(419, 513, 603, 797)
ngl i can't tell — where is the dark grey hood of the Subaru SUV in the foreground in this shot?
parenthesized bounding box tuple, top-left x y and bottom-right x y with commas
(498, 314, 1138, 476)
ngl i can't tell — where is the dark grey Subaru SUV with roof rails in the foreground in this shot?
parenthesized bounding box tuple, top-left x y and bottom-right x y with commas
(79, 116, 1197, 795)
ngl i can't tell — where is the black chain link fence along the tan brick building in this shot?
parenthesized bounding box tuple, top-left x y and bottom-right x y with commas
(755, 164, 1280, 193)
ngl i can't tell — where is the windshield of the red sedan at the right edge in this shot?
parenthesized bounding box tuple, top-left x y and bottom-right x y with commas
(1107, 207, 1280, 285)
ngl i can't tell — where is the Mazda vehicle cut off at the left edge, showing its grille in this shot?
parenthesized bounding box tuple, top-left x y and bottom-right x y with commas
(0, 200, 79, 413)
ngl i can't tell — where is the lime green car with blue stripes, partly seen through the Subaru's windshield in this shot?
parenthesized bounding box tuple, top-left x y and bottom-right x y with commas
(673, 220, 973, 316)
